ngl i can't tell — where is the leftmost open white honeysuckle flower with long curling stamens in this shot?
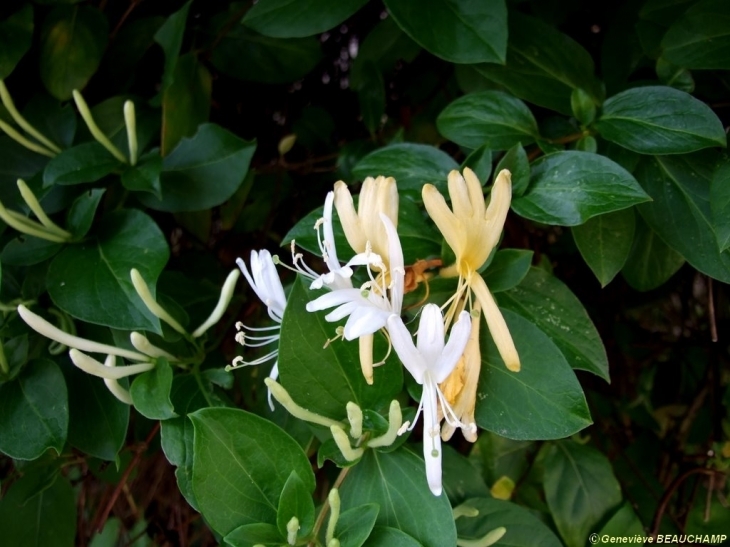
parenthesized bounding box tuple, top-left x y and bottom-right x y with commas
(226, 249, 286, 410)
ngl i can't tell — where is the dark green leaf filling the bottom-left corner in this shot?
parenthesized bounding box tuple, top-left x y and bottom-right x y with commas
(0, 477, 76, 547)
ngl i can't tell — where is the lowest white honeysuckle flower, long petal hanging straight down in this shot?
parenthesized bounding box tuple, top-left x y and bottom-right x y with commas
(388, 304, 471, 496)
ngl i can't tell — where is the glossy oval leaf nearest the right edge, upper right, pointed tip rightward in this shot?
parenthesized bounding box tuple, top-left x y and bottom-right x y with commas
(596, 86, 727, 154)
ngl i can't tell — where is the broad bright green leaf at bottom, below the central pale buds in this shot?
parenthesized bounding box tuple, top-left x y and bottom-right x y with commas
(189, 408, 315, 535)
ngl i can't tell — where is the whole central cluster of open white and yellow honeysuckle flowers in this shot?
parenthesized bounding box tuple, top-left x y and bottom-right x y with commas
(229, 168, 520, 495)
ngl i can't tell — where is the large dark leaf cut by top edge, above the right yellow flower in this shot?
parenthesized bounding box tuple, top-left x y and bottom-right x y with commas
(385, 0, 507, 64)
